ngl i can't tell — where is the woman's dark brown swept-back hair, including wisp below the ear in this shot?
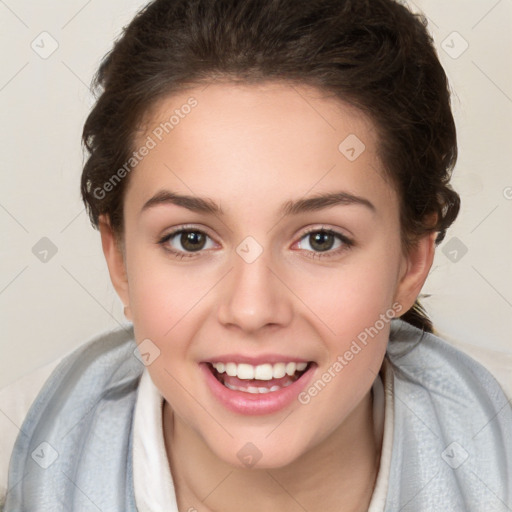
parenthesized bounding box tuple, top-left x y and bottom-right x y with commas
(81, 0, 460, 332)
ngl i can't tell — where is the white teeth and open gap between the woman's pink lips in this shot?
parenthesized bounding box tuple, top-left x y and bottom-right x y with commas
(207, 361, 314, 395)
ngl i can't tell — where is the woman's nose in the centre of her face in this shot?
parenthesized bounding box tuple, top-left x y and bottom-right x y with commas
(218, 247, 292, 333)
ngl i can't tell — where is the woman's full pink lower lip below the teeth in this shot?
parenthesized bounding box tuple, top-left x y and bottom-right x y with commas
(199, 363, 315, 416)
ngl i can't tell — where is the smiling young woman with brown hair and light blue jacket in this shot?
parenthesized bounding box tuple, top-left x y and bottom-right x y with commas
(6, 0, 512, 512)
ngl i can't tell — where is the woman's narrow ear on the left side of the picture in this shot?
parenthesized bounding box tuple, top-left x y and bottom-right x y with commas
(98, 215, 132, 320)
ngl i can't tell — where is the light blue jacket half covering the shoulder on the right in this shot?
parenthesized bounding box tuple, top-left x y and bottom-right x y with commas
(386, 321, 512, 512)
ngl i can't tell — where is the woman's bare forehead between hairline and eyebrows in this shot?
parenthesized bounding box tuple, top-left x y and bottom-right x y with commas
(126, 82, 394, 220)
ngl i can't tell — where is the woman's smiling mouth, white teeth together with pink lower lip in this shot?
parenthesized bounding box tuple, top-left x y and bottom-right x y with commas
(200, 360, 317, 415)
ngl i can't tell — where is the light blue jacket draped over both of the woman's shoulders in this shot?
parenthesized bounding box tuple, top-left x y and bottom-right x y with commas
(5, 320, 512, 512)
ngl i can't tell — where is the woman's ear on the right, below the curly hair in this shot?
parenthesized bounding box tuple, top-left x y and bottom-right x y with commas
(395, 233, 437, 311)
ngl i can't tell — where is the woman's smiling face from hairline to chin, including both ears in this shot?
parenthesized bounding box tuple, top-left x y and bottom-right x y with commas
(102, 83, 432, 467)
